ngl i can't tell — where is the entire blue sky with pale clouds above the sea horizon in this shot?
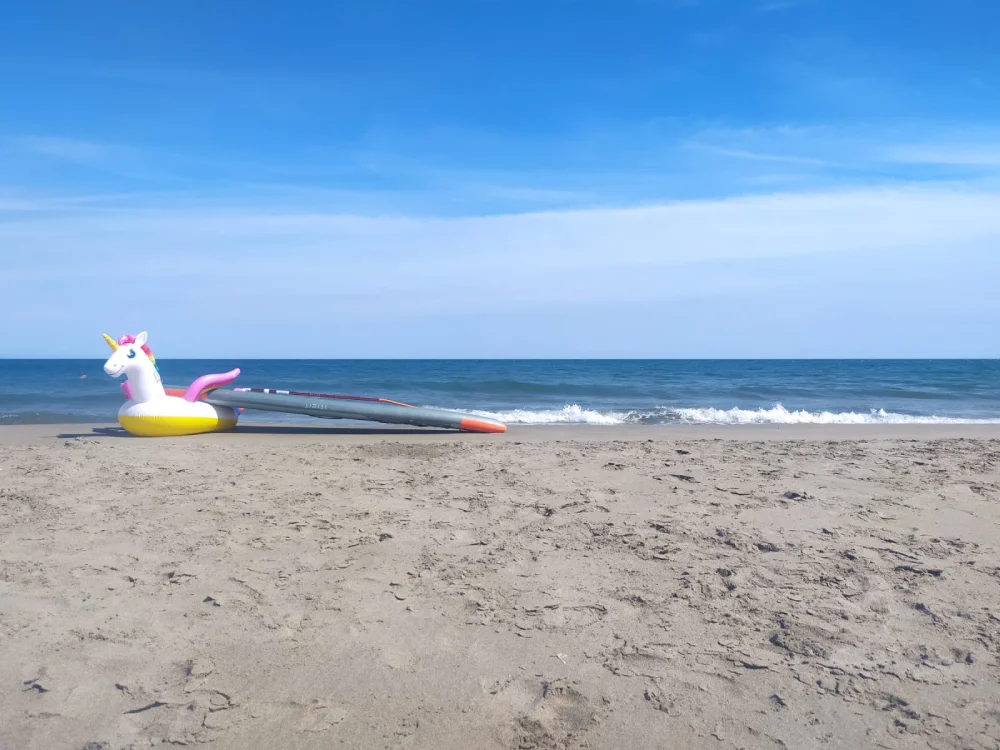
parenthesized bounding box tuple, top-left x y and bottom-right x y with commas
(0, 0, 1000, 360)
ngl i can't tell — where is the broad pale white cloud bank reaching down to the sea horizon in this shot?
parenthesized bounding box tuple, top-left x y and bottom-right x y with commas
(0, 186, 1000, 357)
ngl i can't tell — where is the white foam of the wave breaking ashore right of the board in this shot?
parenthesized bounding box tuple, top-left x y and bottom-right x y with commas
(473, 404, 1000, 425)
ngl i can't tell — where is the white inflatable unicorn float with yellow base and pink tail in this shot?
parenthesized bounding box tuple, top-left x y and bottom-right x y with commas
(104, 331, 240, 437)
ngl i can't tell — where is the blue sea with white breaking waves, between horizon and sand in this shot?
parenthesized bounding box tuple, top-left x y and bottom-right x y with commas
(0, 359, 1000, 425)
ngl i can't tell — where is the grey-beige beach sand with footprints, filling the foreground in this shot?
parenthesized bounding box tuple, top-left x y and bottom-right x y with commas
(0, 426, 1000, 750)
